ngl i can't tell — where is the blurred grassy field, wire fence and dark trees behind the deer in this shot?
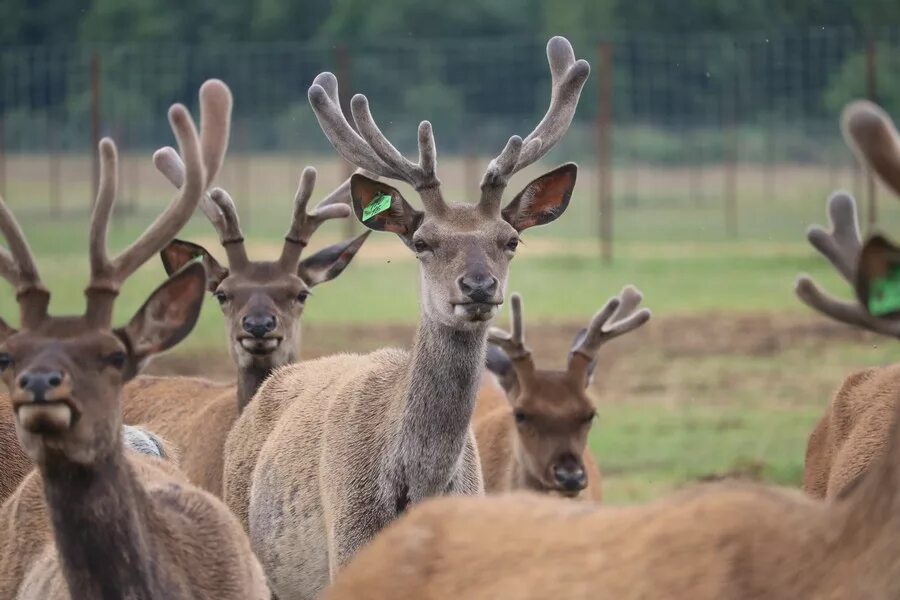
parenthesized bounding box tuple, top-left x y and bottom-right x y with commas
(0, 0, 900, 502)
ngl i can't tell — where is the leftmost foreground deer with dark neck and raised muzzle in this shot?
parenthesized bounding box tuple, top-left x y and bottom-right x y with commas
(0, 80, 270, 599)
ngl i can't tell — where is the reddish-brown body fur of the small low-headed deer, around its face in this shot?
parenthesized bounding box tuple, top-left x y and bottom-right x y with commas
(472, 372, 603, 502)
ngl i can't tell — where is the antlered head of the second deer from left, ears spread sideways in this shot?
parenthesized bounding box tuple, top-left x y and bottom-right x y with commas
(154, 148, 369, 369)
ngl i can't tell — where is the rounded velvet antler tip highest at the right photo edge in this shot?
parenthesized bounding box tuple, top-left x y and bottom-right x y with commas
(841, 100, 900, 195)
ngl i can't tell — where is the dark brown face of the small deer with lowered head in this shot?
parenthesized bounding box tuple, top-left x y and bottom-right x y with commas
(509, 371, 596, 495)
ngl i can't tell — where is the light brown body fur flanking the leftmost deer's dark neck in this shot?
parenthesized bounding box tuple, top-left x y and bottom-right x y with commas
(0, 454, 269, 600)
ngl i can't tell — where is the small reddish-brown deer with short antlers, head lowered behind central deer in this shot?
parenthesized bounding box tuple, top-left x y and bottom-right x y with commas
(472, 286, 650, 501)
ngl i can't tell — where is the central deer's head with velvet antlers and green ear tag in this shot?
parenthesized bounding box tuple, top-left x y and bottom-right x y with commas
(309, 37, 590, 329)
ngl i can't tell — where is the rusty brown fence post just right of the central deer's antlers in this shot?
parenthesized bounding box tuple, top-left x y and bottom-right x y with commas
(596, 42, 613, 265)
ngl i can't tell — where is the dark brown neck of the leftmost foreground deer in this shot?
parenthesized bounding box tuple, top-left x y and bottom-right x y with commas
(40, 440, 167, 598)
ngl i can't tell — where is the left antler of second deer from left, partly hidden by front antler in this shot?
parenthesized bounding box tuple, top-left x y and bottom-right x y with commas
(153, 146, 248, 269)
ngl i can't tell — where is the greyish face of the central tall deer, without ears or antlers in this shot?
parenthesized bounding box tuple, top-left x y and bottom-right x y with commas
(410, 205, 519, 328)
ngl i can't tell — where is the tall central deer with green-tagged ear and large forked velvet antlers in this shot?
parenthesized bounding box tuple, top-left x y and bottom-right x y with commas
(225, 38, 589, 600)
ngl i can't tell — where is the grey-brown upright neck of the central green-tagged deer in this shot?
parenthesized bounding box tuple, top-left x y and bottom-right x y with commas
(395, 317, 487, 505)
